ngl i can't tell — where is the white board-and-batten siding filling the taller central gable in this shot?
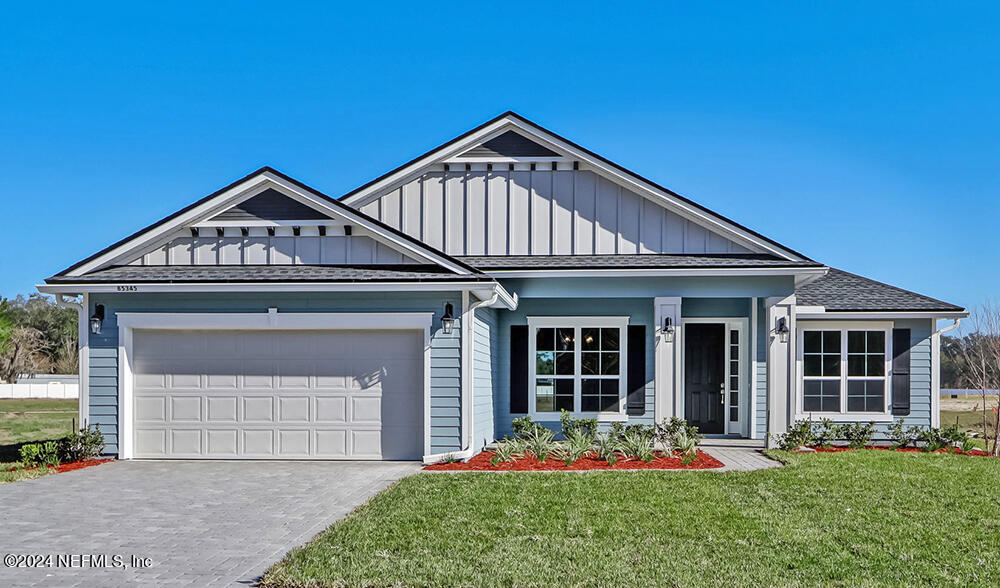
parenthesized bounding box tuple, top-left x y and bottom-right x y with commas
(360, 163, 749, 255)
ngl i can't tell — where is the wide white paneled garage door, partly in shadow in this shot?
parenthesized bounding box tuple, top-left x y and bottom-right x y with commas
(132, 330, 423, 459)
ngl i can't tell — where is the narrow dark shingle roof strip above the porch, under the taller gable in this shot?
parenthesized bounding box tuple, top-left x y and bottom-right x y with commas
(458, 254, 823, 271)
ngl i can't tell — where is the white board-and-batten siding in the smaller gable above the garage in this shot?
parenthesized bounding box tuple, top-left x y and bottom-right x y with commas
(128, 232, 419, 265)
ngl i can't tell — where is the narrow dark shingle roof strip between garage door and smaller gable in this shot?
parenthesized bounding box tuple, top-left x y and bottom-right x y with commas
(46, 264, 493, 284)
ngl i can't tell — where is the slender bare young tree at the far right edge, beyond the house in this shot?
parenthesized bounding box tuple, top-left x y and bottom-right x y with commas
(951, 302, 1000, 455)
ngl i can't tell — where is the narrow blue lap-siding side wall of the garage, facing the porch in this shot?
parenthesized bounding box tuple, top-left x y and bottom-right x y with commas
(472, 308, 498, 450)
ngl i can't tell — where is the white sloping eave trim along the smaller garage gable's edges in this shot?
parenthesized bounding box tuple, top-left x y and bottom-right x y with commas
(56, 167, 480, 277)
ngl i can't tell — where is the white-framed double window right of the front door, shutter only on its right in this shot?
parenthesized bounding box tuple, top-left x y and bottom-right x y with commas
(798, 323, 892, 415)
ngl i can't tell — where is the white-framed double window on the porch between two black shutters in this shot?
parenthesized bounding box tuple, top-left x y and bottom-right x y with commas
(528, 317, 628, 419)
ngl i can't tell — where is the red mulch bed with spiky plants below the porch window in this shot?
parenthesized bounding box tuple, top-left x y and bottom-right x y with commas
(424, 451, 723, 472)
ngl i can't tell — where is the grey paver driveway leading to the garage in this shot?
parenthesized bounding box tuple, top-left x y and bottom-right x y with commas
(0, 461, 419, 586)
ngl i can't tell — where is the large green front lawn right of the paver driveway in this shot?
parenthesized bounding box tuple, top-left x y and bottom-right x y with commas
(264, 451, 1000, 587)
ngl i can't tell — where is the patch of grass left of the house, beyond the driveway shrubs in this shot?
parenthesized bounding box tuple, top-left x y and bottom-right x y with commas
(0, 398, 77, 484)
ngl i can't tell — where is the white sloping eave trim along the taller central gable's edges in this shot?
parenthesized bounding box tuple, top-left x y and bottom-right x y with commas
(340, 112, 811, 261)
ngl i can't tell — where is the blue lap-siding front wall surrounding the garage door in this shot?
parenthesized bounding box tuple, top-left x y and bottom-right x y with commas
(88, 292, 462, 455)
